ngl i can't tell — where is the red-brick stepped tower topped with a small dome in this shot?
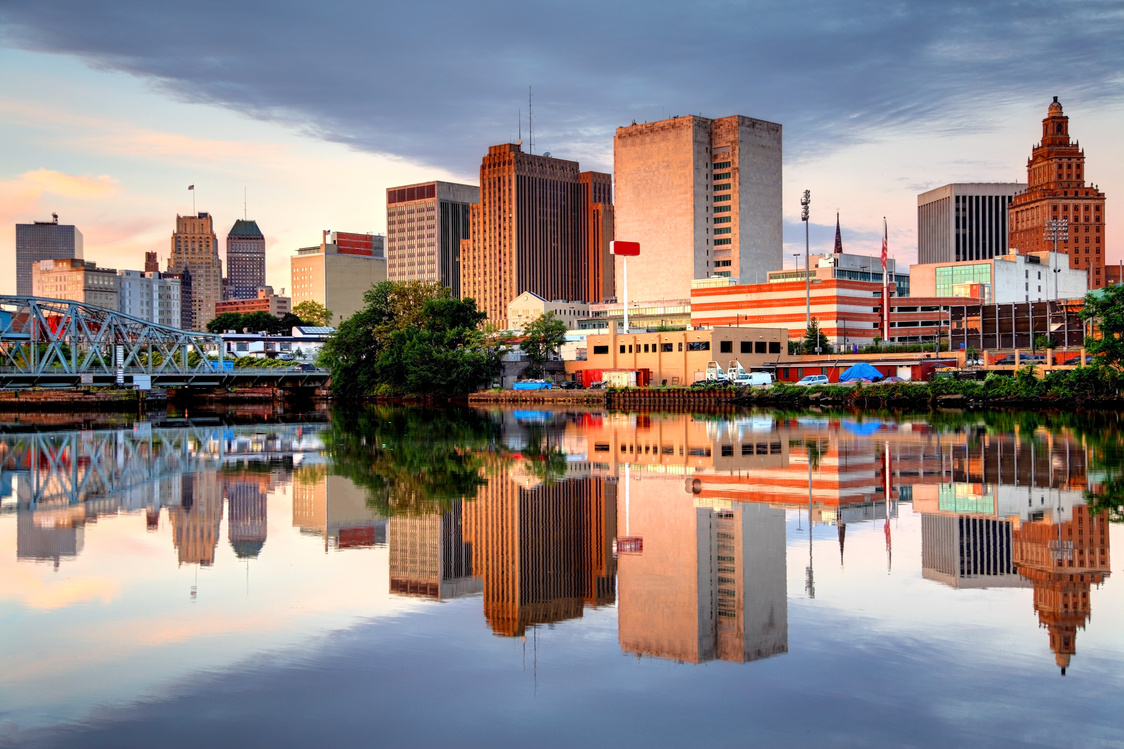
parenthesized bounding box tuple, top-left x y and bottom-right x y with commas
(1009, 97, 1105, 289)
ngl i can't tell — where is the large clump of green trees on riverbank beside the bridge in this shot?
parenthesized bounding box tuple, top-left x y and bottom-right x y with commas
(320, 281, 499, 397)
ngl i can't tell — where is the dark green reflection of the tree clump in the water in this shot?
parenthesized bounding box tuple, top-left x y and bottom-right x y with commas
(324, 406, 500, 517)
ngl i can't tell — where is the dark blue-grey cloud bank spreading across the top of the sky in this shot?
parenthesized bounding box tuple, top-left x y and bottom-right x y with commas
(0, 0, 1124, 175)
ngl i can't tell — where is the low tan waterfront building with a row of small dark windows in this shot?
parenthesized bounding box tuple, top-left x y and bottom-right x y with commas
(582, 327, 788, 385)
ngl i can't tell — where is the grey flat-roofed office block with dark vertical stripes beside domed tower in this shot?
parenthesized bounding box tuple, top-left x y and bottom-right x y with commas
(917, 182, 1026, 263)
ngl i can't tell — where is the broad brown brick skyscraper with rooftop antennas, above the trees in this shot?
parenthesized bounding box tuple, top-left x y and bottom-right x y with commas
(461, 143, 613, 328)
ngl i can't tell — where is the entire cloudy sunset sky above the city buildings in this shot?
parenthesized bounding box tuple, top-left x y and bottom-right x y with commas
(0, 0, 1124, 294)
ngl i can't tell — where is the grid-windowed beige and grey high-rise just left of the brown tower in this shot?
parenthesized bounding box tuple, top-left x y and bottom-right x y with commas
(387, 182, 480, 297)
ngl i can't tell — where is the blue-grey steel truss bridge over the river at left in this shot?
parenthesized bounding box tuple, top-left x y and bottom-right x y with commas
(0, 296, 328, 390)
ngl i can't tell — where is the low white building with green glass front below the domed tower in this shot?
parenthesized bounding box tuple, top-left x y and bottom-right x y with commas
(913, 247, 1087, 305)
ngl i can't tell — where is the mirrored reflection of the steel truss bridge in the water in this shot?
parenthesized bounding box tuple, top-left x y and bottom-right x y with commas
(0, 424, 323, 508)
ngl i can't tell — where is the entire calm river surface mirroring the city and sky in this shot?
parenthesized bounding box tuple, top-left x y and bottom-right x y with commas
(0, 408, 1124, 747)
